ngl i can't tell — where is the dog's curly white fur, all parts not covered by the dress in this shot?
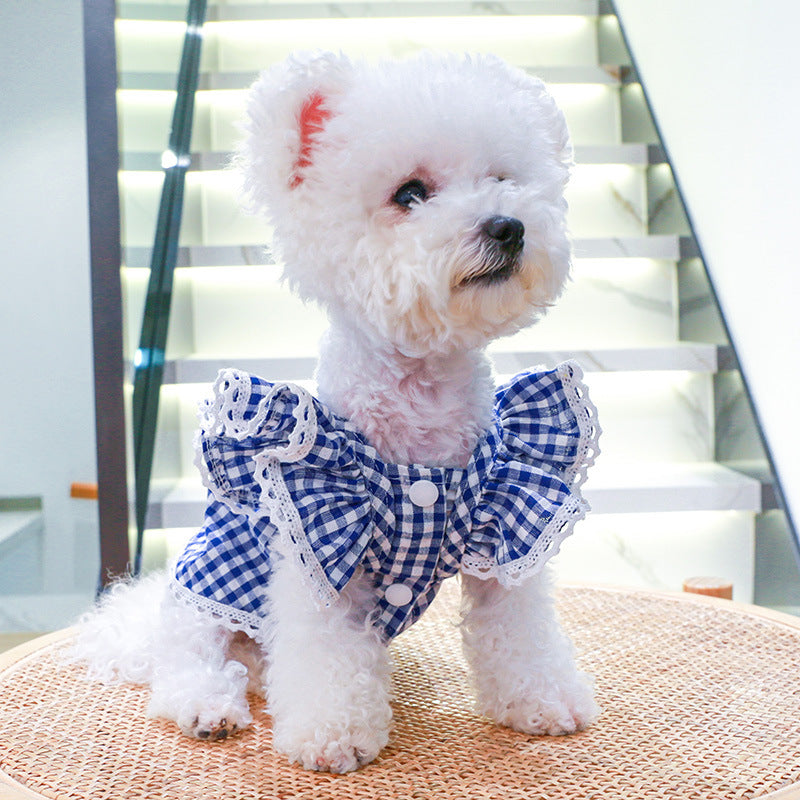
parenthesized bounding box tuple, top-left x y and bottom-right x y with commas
(76, 54, 597, 772)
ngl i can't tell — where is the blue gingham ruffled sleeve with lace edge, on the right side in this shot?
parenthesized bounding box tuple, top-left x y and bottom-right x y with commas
(461, 362, 600, 585)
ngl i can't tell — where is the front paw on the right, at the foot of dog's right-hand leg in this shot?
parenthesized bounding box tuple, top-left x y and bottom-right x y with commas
(494, 672, 600, 736)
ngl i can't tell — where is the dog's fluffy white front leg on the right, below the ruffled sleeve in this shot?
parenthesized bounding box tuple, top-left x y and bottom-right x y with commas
(462, 571, 598, 735)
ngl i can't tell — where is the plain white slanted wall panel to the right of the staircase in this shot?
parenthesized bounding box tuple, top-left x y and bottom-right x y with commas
(616, 0, 800, 536)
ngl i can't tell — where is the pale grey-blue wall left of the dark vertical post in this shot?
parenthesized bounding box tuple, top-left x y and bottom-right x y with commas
(0, 0, 96, 591)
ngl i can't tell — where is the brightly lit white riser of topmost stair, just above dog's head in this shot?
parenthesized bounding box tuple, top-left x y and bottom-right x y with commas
(116, 17, 599, 74)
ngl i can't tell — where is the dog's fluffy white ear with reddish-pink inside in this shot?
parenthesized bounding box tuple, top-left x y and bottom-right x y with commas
(235, 53, 353, 210)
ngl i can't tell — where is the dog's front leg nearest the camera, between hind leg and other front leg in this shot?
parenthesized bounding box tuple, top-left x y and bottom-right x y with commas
(264, 555, 391, 772)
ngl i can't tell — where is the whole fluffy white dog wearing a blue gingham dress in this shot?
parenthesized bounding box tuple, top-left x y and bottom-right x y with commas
(77, 54, 599, 772)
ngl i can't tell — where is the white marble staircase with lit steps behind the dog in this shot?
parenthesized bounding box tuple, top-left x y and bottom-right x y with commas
(117, 0, 763, 601)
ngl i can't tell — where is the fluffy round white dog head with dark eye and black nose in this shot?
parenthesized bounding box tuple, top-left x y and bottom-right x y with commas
(238, 54, 571, 356)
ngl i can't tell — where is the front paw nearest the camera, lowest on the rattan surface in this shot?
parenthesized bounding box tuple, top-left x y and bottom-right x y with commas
(274, 729, 389, 773)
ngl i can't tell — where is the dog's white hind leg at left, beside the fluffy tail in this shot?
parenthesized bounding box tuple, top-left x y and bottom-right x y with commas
(147, 597, 253, 739)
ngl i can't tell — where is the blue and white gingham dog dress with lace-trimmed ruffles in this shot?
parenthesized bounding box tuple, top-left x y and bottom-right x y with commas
(172, 362, 600, 640)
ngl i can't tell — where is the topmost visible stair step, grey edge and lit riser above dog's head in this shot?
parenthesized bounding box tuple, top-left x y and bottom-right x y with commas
(116, 10, 618, 81)
